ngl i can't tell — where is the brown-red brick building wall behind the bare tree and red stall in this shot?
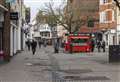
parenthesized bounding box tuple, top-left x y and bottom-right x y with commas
(68, 0, 99, 32)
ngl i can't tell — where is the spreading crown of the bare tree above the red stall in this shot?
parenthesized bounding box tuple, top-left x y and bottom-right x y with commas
(36, 0, 98, 33)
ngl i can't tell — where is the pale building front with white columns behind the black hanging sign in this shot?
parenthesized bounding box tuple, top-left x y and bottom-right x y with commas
(10, 0, 23, 56)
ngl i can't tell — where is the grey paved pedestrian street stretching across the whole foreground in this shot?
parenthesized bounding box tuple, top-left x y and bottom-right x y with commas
(0, 46, 120, 82)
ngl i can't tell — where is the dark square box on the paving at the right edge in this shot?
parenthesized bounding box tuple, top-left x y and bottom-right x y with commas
(109, 45, 120, 62)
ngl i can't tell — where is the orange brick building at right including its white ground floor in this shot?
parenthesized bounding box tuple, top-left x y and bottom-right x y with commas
(99, 0, 118, 47)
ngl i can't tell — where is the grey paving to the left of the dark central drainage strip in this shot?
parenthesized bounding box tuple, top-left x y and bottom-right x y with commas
(0, 46, 51, 82)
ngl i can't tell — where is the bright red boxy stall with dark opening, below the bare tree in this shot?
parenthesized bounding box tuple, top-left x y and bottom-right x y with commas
(65, 34, 92, 52)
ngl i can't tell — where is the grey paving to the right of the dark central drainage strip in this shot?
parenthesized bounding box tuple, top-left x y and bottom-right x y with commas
(54, 47, 120, 82)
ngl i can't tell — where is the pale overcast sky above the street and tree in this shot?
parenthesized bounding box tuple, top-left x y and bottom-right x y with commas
(24, 0, 66, 20)
